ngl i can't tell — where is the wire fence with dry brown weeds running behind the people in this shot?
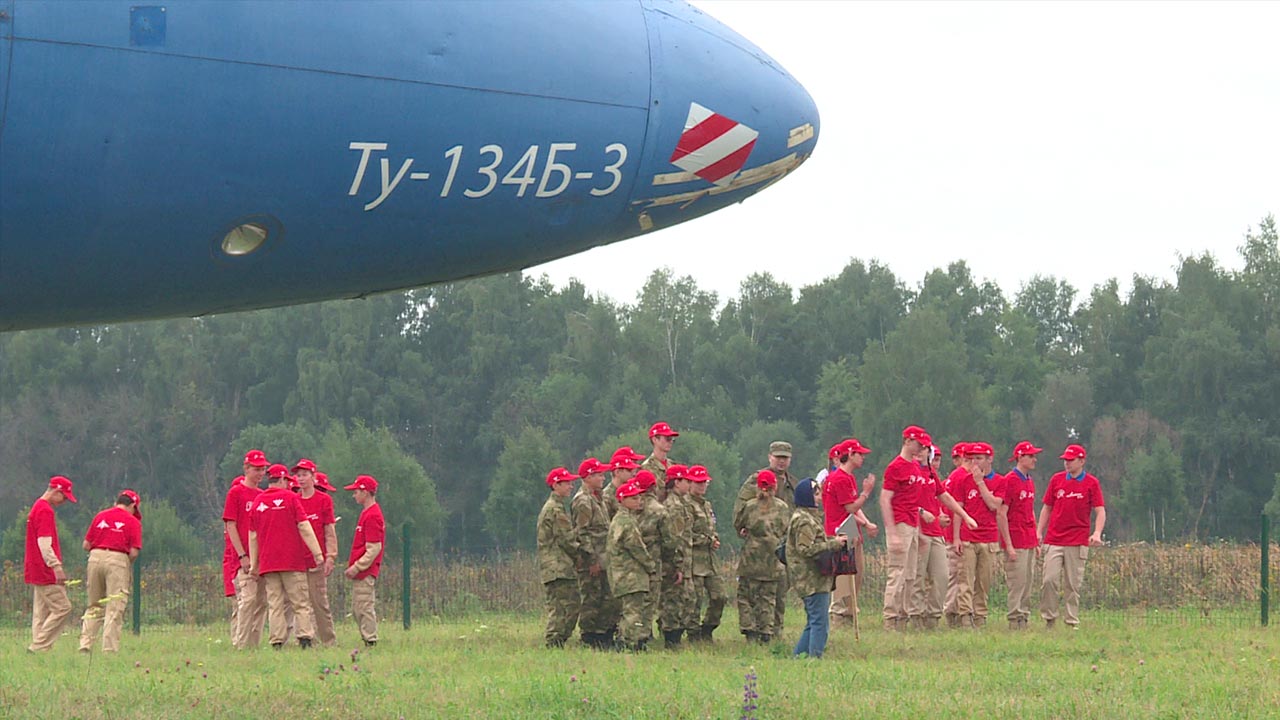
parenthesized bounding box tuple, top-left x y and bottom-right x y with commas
(0, 543, 1280, 630)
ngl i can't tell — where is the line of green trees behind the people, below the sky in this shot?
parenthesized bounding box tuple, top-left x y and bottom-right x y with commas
(0, 217, 1280, 559)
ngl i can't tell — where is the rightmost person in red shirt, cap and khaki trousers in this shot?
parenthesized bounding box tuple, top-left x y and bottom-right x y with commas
(1037, 445, 1107, 630)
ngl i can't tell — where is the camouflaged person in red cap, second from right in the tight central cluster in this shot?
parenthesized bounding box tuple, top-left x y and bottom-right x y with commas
(659, 464, 698, 650)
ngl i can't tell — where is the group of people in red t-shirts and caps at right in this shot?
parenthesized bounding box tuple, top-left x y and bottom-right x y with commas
(822, 425, 1106, 630)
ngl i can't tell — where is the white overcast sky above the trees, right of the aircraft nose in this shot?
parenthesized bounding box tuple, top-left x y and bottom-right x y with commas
(529, 0, 1280, 304)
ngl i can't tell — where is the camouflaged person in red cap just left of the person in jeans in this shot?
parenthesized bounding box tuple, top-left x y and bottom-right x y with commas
(733, 470, 791, 643)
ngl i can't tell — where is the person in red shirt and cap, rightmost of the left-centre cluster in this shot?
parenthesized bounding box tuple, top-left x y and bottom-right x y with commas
(342, 475, 387, 647)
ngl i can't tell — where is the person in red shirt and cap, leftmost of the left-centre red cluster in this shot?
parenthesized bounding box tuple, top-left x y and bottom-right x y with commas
(223, 450, 269, 650)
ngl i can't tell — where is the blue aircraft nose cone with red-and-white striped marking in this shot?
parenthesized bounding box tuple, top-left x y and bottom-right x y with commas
(632, 1, 819, 229)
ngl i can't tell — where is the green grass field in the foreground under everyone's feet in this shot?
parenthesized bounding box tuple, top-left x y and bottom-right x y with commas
(0, 614, 1280, 720)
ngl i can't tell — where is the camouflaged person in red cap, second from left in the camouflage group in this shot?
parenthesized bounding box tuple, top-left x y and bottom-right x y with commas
(570, 457, 618, 650)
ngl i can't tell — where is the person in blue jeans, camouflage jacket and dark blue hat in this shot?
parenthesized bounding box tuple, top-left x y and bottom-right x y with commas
(786, 479, 849, 659)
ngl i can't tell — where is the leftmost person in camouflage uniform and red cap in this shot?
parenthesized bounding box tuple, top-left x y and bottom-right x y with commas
(538, 468, 581, 647)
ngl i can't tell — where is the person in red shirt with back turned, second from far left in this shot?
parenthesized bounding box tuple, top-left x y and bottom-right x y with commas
(81, 489, 142, 652)
